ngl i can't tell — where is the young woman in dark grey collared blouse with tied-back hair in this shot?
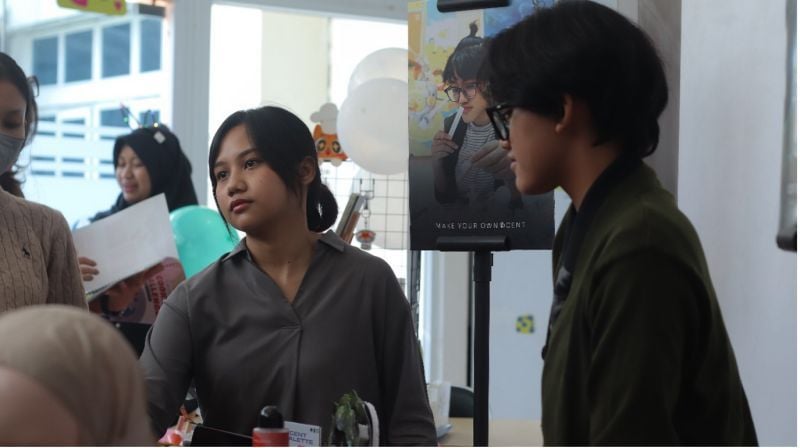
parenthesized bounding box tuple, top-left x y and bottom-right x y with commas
(141, 107, 436, 445)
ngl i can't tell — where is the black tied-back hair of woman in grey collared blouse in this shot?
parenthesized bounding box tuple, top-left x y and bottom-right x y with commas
(208, 106, 339, 232)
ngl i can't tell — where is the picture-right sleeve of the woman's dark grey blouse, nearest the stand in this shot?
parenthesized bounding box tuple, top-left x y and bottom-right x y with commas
(378, 265, 437, 446)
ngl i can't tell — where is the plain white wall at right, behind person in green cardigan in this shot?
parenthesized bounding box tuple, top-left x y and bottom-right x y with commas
(678, 0, 797, 445)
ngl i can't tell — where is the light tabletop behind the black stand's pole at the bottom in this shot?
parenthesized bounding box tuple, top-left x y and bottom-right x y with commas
(439, 418, 543, 446)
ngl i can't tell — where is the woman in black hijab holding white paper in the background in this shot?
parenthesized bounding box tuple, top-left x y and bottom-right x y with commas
(78, 125, 197, 314)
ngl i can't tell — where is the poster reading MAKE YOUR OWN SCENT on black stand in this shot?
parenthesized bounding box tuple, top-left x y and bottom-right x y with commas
(408, 0, 554, 250)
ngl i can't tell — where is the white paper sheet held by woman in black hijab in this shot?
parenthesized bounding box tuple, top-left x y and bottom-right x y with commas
(72, 194, 178, 294)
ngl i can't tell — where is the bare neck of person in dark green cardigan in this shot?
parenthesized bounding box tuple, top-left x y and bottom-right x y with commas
(561, 143, 622, 211)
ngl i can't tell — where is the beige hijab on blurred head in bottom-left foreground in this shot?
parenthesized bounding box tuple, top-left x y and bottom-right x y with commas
(0, 305, 156, 446)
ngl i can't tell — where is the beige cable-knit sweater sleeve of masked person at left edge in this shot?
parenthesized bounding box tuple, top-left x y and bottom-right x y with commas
(47, 211, 87, 309)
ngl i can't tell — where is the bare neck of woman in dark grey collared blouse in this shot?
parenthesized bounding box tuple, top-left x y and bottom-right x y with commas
(245, 214, 319, 280)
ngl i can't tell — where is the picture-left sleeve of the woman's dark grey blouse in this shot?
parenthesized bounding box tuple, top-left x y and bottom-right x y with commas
(139, 284, 192, 436)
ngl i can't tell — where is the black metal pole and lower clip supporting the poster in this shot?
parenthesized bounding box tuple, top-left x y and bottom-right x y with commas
(436, 236, 509, 446)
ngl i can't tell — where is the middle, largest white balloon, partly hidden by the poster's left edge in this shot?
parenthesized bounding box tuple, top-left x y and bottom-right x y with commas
(337, 78, 408, 174)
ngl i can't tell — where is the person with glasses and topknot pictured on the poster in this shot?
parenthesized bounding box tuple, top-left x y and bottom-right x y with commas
(431, 22, 522, 210)
